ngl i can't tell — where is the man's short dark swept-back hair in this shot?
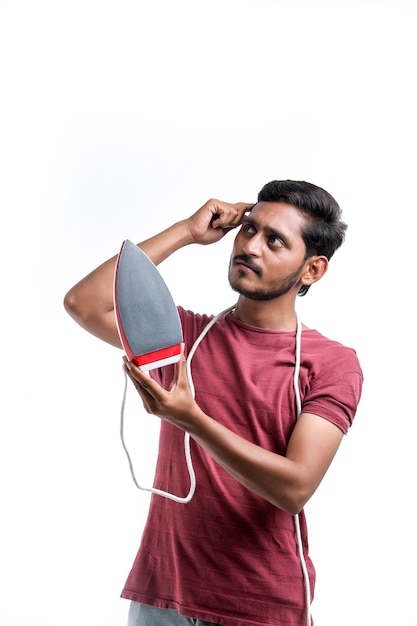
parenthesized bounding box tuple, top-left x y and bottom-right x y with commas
(258, 180, 347, 296)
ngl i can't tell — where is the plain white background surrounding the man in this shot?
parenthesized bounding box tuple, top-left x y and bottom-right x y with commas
(0, 0, 417, 626)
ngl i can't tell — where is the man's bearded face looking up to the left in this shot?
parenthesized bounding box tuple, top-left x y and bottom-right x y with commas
(229, 202, 306, 300)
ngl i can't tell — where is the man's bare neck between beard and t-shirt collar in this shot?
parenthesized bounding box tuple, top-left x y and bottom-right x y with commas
(234, 295, 297, 332)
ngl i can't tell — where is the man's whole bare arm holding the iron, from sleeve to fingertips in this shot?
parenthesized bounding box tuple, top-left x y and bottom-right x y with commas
(125, 348, 343, 515)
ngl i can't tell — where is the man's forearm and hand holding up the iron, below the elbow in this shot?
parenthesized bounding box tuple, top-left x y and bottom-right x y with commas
(125, 354, 316, 514)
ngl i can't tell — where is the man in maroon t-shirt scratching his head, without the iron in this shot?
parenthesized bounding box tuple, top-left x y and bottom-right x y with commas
(64, 181, 363, 626)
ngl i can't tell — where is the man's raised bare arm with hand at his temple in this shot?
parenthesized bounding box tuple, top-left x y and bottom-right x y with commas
(64, 200, 253, 347)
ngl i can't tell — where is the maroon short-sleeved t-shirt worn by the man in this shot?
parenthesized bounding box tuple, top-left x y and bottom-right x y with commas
(122, 308, 363, 626)
